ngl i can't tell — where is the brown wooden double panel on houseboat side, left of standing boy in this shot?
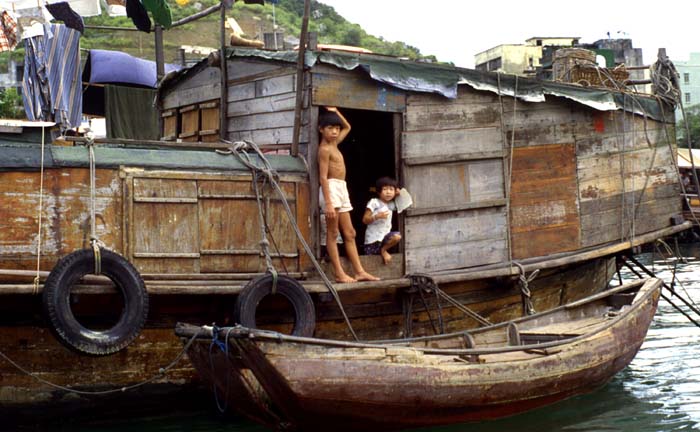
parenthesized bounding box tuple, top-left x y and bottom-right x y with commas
(126, 172, 309, 273)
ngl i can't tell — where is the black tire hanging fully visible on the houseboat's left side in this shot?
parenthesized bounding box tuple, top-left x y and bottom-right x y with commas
(43, 248, 148, 356)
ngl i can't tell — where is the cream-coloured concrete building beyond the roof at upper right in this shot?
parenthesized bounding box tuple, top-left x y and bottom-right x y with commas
(474, 36, 581, 75)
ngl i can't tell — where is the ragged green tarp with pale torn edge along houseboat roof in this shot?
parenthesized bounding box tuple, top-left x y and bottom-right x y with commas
(223, 48, 673, 122)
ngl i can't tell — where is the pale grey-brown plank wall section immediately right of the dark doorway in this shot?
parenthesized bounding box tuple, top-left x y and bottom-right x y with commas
(402, 86, 508, 273)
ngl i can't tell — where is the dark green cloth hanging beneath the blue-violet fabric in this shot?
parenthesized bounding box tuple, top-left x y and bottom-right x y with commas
(105, 85, 160, 140)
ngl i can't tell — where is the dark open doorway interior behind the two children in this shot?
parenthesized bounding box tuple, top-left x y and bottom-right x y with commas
(340, 108, 398, 254)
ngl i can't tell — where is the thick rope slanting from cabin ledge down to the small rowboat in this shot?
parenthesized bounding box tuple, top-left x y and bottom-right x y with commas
(216, 141, 359, 340)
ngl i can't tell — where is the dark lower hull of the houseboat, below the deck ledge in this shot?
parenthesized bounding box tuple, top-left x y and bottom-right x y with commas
(0, 253, 615, 407)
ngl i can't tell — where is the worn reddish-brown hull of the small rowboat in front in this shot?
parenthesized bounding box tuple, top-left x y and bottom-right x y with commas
(180, 280, 660, 430)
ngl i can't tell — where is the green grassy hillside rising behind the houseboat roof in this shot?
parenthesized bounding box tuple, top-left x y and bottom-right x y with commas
(5, 0, 434, 62)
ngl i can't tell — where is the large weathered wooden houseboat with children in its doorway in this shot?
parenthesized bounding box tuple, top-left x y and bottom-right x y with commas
(0, 49, 690, 409)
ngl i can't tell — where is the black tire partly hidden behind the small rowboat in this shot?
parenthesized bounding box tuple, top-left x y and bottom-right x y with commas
(233, 274, 316, 337)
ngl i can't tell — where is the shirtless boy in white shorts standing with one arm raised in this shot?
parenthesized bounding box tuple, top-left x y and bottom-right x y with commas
(318, 107, 379, 283)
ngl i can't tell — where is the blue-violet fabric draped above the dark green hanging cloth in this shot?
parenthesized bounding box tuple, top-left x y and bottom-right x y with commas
(83, 49, 182, 88)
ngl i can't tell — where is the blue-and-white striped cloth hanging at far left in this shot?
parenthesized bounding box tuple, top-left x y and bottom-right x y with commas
(22, 24, 83, 130)
